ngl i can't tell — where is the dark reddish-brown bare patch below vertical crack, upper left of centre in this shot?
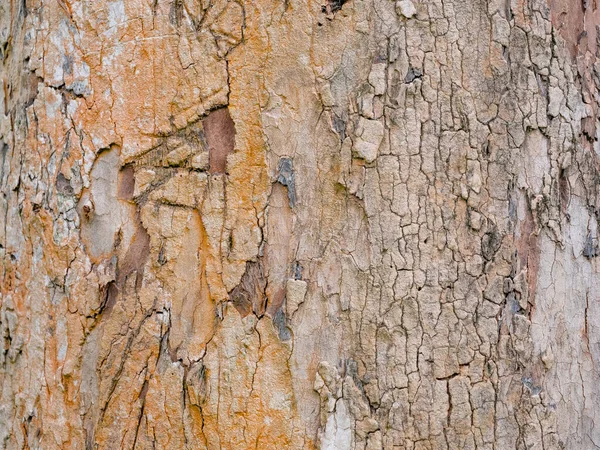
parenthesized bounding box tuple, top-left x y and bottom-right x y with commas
(203, 108, 235, 173)
